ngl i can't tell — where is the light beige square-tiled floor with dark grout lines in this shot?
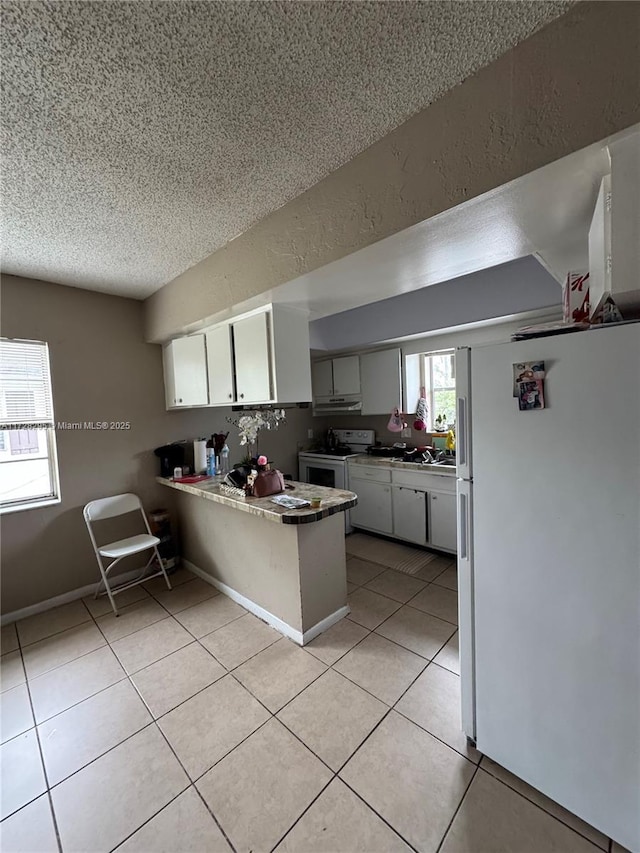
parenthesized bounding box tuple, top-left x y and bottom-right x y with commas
(0, 544, 620, 853)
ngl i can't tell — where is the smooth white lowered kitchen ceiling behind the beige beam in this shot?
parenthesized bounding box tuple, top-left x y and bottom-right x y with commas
(247, 125, 640, 320)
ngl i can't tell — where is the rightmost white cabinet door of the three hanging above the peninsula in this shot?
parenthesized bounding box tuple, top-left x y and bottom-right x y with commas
(233, 312, 274, 405)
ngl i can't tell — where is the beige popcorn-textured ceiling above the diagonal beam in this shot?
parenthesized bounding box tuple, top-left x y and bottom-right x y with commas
(0, 0, 570, 298)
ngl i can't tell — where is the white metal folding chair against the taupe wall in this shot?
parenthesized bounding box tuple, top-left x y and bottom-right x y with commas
(82, 494, 171, 616)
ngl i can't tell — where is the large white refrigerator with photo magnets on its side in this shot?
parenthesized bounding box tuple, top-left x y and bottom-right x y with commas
(456, 324, 640, 851)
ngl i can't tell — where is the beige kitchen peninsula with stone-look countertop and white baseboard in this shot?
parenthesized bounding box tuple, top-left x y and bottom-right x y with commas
(157, 477, 357, 645)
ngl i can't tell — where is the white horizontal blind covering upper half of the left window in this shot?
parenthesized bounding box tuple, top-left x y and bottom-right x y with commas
(0, 338, 54, 428)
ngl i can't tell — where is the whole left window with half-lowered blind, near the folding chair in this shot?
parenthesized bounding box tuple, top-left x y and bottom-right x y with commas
(0, 338, 60, 512)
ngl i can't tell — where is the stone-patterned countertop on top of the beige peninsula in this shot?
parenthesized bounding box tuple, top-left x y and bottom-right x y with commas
(156, 477, 358, 524)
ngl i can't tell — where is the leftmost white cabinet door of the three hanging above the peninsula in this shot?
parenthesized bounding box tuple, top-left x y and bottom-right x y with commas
(163, 335, 209, 409)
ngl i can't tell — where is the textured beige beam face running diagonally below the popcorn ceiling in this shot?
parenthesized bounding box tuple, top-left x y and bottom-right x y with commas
(145, 2, 640, 341)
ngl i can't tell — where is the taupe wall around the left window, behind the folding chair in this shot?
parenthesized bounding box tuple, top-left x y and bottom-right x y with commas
(0, 276, 311, 613)
